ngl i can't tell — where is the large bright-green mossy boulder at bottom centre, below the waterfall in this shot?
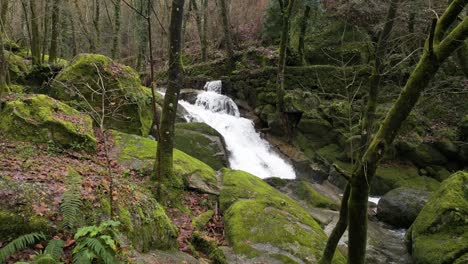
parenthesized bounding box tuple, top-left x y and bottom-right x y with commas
(220, 169, 345, 263)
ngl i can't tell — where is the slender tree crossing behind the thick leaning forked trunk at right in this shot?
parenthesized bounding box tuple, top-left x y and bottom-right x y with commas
(319, 0, 399, 264)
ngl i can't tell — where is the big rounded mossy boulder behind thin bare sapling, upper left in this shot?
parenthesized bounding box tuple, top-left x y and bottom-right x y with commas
(50, 54, 153, 135)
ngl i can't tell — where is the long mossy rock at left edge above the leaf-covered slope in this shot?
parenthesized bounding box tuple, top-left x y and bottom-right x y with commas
(0, 95, 97, 151)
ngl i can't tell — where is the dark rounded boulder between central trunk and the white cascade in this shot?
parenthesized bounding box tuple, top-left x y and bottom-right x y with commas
(174, 123, 229, 170)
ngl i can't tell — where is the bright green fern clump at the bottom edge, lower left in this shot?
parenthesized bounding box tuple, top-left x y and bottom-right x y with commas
(73, 221, 120, 264)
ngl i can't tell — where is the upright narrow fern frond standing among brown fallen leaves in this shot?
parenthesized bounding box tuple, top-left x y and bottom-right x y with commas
(60, 170, 82, 229)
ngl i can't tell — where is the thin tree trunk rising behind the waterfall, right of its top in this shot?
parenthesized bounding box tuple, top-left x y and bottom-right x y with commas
(276, 0, 294, 114)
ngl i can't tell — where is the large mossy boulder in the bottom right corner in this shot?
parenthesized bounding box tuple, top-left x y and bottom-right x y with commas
(407, 171, 468, 264)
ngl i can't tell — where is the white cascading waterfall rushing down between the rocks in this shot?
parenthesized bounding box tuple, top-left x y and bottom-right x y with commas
(180, 81, 296, 179)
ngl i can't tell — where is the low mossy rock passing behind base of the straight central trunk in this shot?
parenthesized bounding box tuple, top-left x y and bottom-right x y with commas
(111, 131, 219, 194)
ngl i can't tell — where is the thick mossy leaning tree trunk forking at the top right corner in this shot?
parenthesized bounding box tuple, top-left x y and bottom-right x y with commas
(348, 0, 468, 264)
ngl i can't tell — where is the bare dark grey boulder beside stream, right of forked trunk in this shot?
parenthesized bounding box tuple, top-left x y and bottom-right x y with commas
(377, 187, 430, 228)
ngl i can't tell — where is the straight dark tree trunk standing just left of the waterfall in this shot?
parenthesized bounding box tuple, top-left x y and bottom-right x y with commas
(155, 0, 185, 190)
